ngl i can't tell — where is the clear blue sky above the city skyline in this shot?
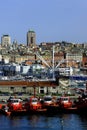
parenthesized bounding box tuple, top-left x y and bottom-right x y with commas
(0, 0, 87, 44)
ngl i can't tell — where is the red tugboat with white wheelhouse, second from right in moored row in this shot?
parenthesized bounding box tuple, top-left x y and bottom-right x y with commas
(47, 96, 77, 114)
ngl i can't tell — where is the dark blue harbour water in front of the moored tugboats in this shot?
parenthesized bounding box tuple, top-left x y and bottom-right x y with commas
(0, 114, 87, 130)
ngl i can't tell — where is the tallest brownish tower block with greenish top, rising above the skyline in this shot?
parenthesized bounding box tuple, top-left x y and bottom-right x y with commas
(27, 30, 36, 48)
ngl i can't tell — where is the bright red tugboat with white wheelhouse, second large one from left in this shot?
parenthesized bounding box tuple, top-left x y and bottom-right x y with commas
(25, 97, 46, 114)
